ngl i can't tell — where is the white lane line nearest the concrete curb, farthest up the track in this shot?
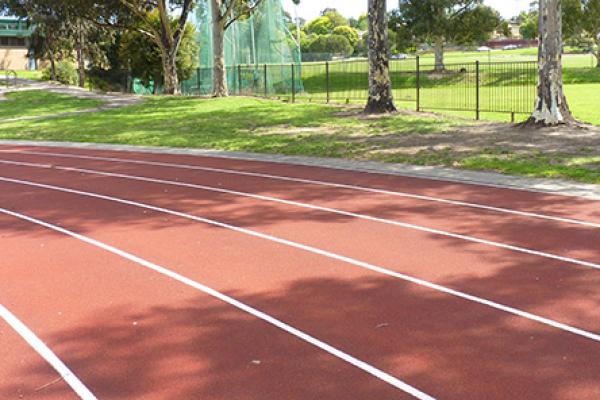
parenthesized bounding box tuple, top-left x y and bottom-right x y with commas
(0, 149, 600, 228)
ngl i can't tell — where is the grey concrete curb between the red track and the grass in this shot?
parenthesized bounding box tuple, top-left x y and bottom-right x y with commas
(0, 140, 600, 200)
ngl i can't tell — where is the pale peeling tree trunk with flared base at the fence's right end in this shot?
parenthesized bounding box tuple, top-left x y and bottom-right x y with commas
(527, 0, 574, 126)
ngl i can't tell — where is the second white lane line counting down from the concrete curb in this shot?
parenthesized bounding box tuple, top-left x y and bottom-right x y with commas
(0, 160, 600, 270)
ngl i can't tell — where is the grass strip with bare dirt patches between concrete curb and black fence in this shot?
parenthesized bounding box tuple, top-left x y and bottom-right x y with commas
(0, 94, 600, 183)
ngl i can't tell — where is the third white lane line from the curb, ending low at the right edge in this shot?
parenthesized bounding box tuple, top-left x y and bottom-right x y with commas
(0, 178, 600, 342)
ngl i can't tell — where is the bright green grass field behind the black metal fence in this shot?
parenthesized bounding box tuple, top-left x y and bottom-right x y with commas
(272, 48, 600, 125)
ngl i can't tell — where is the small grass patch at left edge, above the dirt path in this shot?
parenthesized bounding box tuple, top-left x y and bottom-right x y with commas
(0, 90, 104, 119)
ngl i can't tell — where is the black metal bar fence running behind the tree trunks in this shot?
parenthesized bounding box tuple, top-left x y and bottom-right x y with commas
(182, 57, 537, 118)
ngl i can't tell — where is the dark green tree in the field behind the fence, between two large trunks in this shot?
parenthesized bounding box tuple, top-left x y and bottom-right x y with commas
(399, 0, 501, 71)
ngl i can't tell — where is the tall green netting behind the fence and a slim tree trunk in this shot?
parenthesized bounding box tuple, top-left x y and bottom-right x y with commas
(177, 0, 302, 95)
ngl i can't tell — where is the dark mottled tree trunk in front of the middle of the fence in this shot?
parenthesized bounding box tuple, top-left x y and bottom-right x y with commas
(365, 0, 396, 114)
